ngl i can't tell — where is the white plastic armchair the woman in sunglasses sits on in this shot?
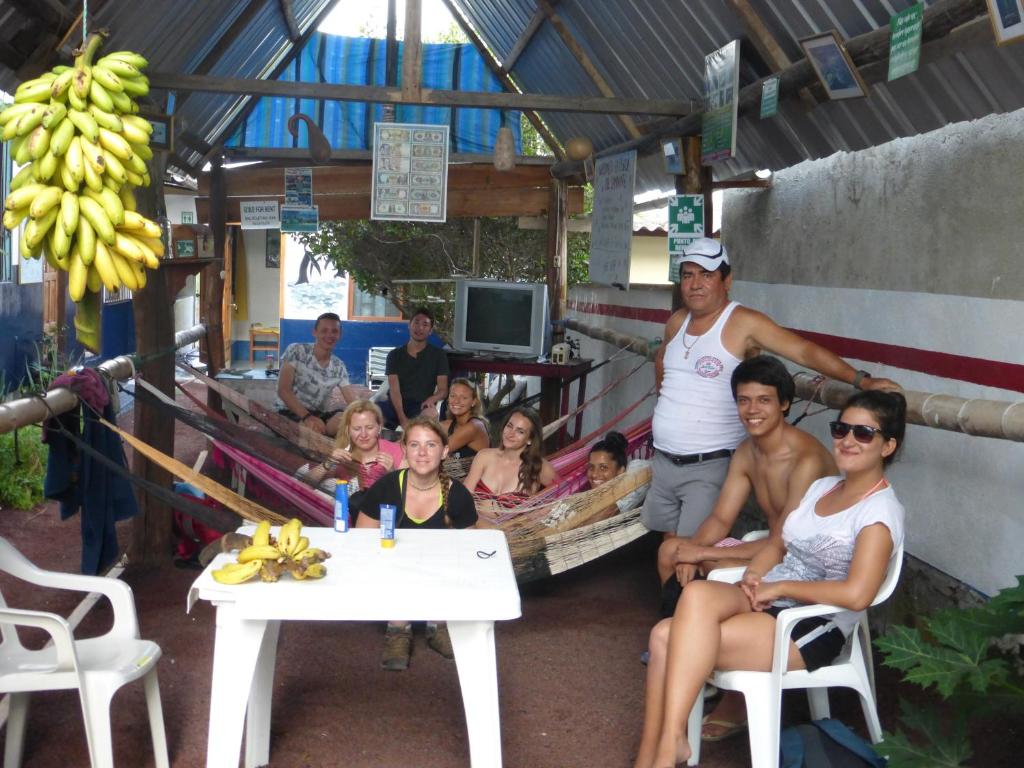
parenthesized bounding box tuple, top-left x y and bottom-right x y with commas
(686, 546, 903, 768)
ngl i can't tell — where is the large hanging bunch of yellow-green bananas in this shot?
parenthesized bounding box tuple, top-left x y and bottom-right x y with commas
(0, 34, 164, 350)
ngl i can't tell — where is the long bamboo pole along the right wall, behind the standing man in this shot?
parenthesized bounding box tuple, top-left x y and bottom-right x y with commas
(563, 318, 1024, 442)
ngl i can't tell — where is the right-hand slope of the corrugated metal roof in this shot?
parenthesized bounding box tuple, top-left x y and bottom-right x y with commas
(457, 0, 1024, 193)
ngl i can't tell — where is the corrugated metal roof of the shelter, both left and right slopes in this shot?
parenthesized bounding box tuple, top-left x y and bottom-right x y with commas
(0, 0, 1024, 193)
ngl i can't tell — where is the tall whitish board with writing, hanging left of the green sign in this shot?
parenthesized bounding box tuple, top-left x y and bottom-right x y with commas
(590, 150, 637, 289)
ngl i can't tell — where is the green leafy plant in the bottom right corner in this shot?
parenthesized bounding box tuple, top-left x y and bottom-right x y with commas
(876, 577, 1024, 768)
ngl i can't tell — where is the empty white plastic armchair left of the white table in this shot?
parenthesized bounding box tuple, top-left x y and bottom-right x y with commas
(0, 538, 169, 768)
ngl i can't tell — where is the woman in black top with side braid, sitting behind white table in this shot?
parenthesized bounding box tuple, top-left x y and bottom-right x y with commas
(355, 416, 476, 672)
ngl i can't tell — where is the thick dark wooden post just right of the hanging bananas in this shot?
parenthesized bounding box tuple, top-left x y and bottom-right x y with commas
(129, 153, 176, 567)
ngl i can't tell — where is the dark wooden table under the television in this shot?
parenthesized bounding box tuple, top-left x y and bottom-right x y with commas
(449, 352, 594, 447)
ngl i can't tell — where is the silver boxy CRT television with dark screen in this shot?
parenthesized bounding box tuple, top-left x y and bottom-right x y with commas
(452, 279, 551, 358)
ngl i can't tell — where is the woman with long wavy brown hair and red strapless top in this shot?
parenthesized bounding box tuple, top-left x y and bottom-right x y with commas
(464, 407, 558, 518)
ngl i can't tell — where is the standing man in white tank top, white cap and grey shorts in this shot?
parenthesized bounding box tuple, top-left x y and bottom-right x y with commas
(642, 238, 899, 538)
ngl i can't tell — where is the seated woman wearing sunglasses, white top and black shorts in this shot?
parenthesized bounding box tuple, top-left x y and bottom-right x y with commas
(635, 390, 906, 768)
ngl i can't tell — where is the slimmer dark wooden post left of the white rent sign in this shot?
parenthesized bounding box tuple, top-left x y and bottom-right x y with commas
(200, 157, 230, 411)
